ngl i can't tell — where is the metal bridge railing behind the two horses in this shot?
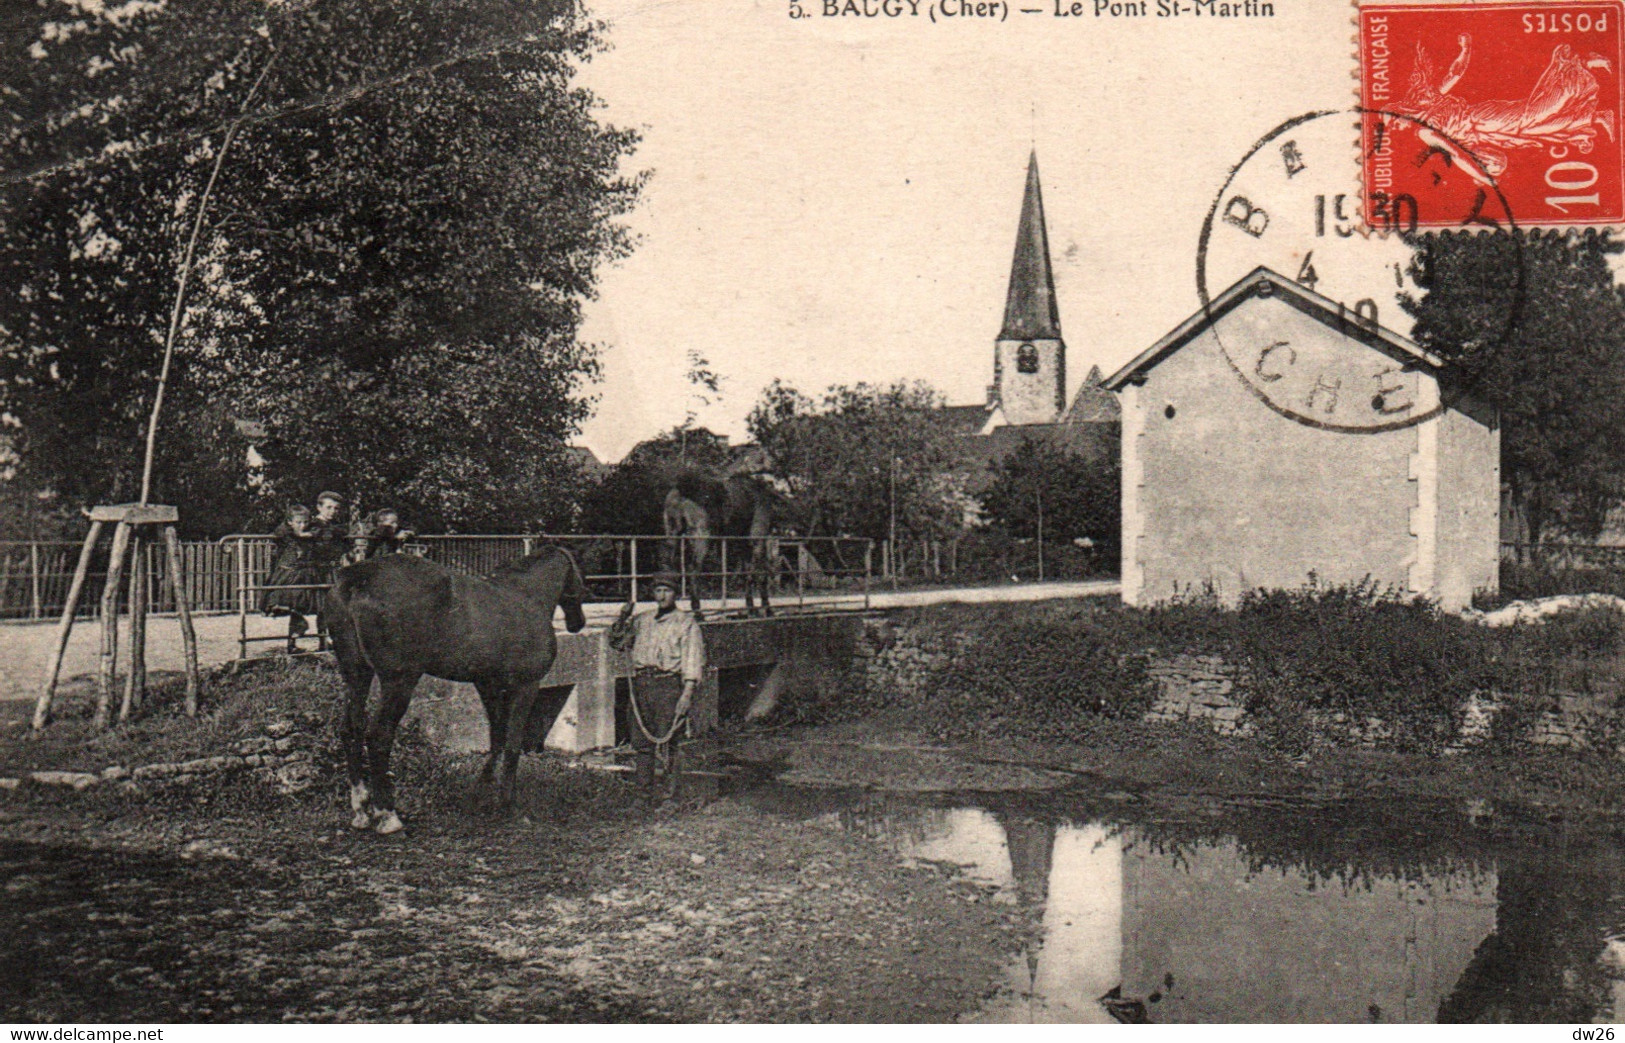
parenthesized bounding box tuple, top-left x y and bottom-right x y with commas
(221, 534, 876, 658)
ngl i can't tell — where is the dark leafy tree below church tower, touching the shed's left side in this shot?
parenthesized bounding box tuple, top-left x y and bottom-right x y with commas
(982, 439, 1121, 560)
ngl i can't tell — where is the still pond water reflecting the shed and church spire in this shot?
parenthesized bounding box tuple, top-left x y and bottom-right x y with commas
(829, 801, 1625, 1024)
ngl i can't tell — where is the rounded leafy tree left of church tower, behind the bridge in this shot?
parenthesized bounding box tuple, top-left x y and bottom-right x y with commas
(748, 380, 964, 539)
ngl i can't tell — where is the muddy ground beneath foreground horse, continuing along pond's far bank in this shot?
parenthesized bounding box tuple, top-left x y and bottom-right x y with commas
(0, 656, 1625, 1022)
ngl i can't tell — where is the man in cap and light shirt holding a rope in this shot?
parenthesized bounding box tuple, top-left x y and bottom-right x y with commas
(609, 572, 705, 788)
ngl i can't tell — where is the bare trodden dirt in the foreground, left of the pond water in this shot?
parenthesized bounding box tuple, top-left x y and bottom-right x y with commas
(0, 770, 1022, 1022)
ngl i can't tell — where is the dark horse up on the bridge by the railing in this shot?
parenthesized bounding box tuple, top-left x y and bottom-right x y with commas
(663, 470, 778, 616)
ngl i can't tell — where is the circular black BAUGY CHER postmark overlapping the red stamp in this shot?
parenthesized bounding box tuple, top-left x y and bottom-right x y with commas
(1196, 109, 1523, 434)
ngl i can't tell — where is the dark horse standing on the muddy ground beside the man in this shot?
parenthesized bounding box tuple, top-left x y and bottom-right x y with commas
(327, 547, 587, 833)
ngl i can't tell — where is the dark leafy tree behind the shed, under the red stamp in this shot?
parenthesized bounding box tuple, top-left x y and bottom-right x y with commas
(1406, 232, 1625, 539)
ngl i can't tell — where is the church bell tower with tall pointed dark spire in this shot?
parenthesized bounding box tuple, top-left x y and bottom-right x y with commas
(990, 149, 1066, 424)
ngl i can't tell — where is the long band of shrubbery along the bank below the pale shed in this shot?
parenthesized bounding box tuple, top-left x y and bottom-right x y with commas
(866, 577, 1625, 752)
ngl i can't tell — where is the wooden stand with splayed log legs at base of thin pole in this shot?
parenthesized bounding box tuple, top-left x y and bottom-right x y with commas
(34, 504, 198, 731)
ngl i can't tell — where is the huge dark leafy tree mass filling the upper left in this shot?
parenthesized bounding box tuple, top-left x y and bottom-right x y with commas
(0, 0, 640, 528)
